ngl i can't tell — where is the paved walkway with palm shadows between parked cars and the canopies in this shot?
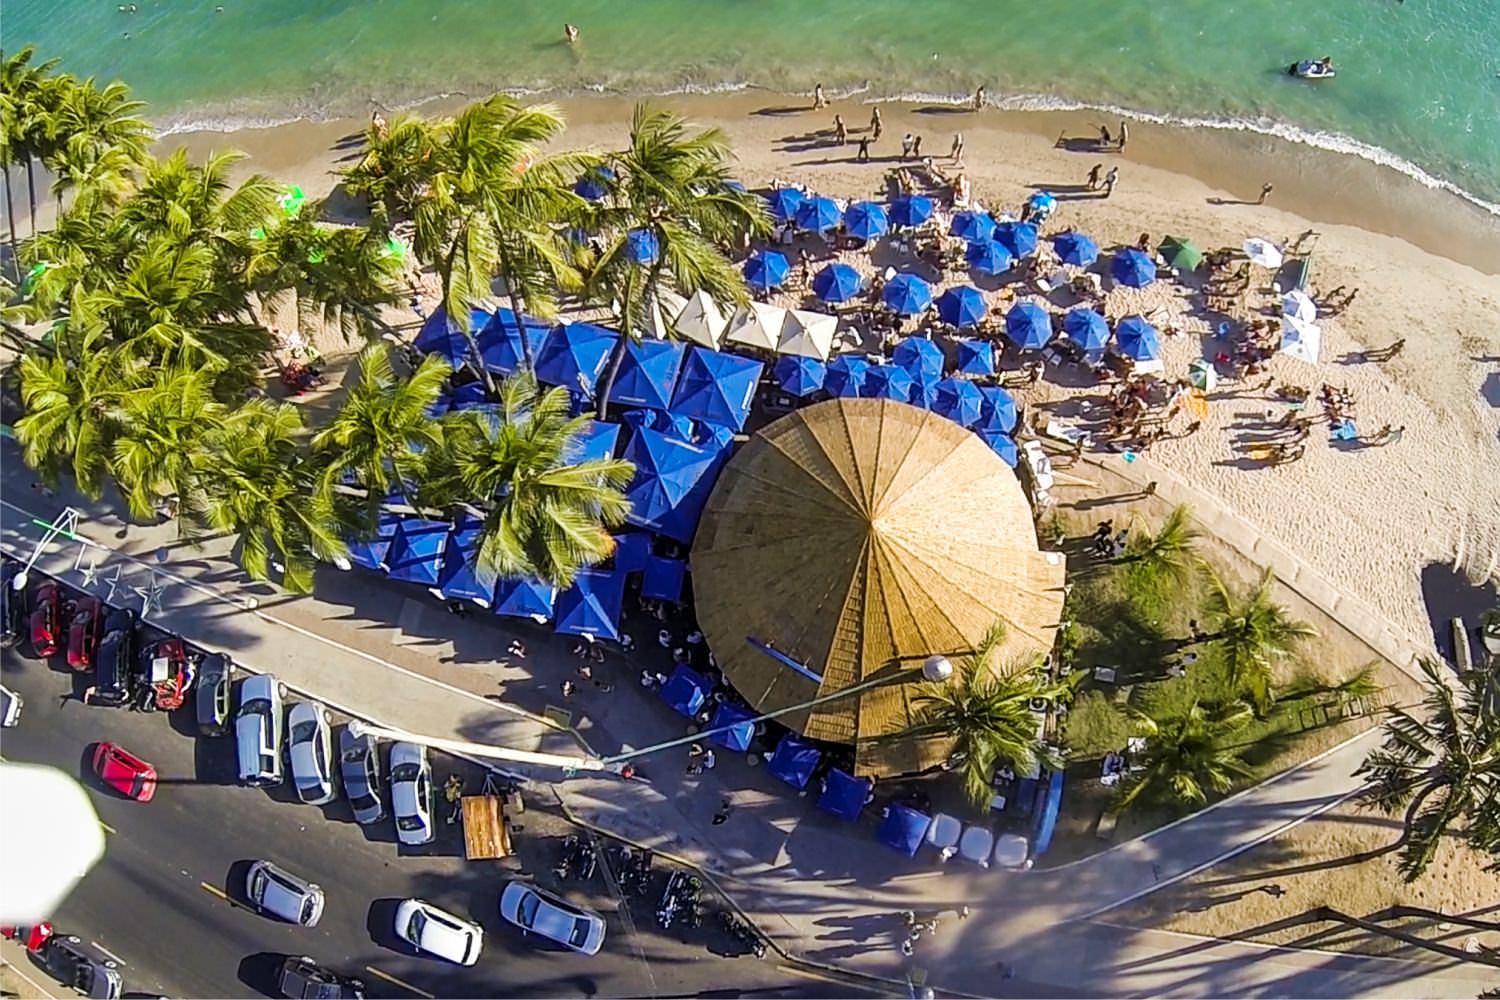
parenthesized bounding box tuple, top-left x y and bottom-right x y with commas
(0, 455, 1493, 997)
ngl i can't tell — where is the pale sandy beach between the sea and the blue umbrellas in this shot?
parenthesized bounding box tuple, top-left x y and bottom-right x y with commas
(164, 93, 1500, 656)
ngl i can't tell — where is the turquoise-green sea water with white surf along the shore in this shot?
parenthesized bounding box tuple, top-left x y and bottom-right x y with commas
(11, 0, 1500, 211)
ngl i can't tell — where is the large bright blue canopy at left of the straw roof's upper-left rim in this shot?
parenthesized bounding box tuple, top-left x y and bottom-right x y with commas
(623, 427, 725, 542)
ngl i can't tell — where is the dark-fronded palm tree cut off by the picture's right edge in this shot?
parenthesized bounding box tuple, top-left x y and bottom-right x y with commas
(1356, 658, 1500, 882)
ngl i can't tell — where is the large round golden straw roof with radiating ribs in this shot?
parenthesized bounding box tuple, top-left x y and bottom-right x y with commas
(693, 399, 1064, 774)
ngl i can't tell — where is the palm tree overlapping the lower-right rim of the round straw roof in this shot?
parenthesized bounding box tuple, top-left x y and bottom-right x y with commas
(879, 622, 1070, 810)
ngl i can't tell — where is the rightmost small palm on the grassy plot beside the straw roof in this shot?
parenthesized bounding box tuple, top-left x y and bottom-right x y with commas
(1206, 568, 1317, 712)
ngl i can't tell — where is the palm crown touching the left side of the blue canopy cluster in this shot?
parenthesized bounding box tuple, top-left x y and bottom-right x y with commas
(312, 343, 452, 504)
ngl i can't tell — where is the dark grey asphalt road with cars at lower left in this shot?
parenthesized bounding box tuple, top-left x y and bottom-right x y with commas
(3, 614, 852, 997)
